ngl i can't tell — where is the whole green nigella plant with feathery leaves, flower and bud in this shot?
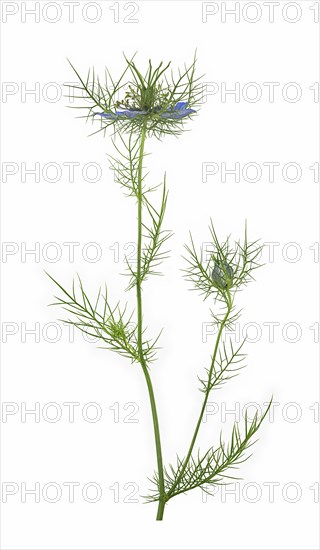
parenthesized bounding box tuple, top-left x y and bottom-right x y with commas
(49, 57, 271, 520)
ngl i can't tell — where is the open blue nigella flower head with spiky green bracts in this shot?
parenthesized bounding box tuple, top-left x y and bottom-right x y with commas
(68, 54, 202, 137)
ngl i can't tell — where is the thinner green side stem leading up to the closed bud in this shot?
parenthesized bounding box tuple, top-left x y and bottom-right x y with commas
(167, 289, 232, 499)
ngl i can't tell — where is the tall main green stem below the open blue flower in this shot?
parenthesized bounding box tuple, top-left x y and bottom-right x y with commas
(136, 125, 166, 520)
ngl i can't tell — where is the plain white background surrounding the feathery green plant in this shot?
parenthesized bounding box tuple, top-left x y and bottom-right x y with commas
(1, 1, 319, 550)
